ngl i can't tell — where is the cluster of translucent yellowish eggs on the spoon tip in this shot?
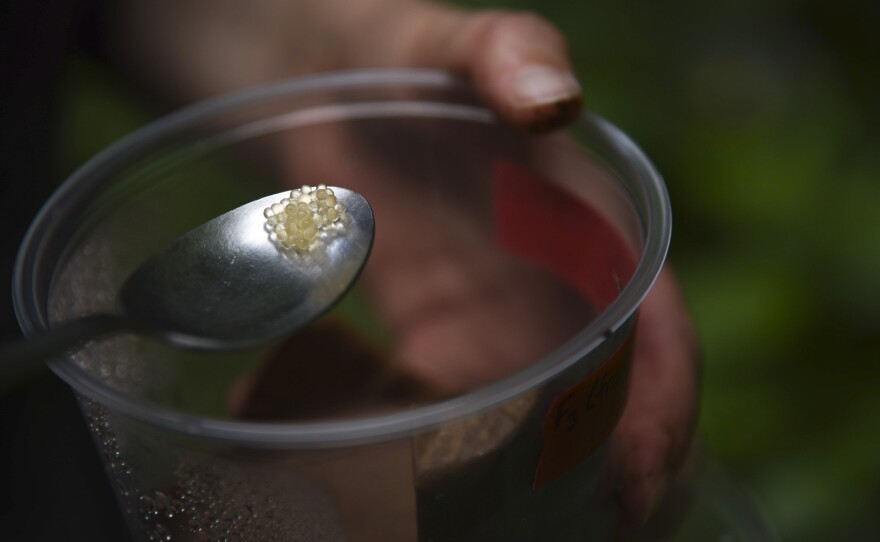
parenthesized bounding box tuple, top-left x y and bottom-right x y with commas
(263, 184, 345, 251)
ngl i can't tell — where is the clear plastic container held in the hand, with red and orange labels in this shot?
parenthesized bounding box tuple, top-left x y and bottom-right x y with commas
(14, 71, 670, 542)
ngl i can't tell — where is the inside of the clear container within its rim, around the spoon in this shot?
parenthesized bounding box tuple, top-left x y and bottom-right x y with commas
(49, 85, 641, 421)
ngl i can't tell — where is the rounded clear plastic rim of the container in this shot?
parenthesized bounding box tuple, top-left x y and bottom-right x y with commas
(13, 69, 672, 449)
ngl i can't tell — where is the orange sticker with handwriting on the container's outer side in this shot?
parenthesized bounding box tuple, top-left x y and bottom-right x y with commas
(533, 334, 635, 487)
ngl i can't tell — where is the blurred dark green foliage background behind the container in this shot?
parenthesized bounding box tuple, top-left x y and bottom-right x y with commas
(58, 0, 880, 541)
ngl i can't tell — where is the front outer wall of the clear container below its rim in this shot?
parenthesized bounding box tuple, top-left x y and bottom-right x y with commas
(82, 338, 623, 542)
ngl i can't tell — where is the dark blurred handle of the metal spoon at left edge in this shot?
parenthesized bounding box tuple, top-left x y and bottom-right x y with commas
(0, 314, 130, 393)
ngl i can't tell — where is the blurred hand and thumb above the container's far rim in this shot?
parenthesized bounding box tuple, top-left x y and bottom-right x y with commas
(117, 0, 581, 130)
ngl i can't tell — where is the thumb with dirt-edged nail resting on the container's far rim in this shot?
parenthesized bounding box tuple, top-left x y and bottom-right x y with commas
(395, 4, 581, 131)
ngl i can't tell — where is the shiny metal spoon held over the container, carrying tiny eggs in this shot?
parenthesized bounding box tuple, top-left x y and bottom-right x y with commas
(0, 187, 374, 384)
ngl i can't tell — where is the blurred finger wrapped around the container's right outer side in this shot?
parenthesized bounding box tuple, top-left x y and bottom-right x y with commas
(614, 269, 699, 523)
